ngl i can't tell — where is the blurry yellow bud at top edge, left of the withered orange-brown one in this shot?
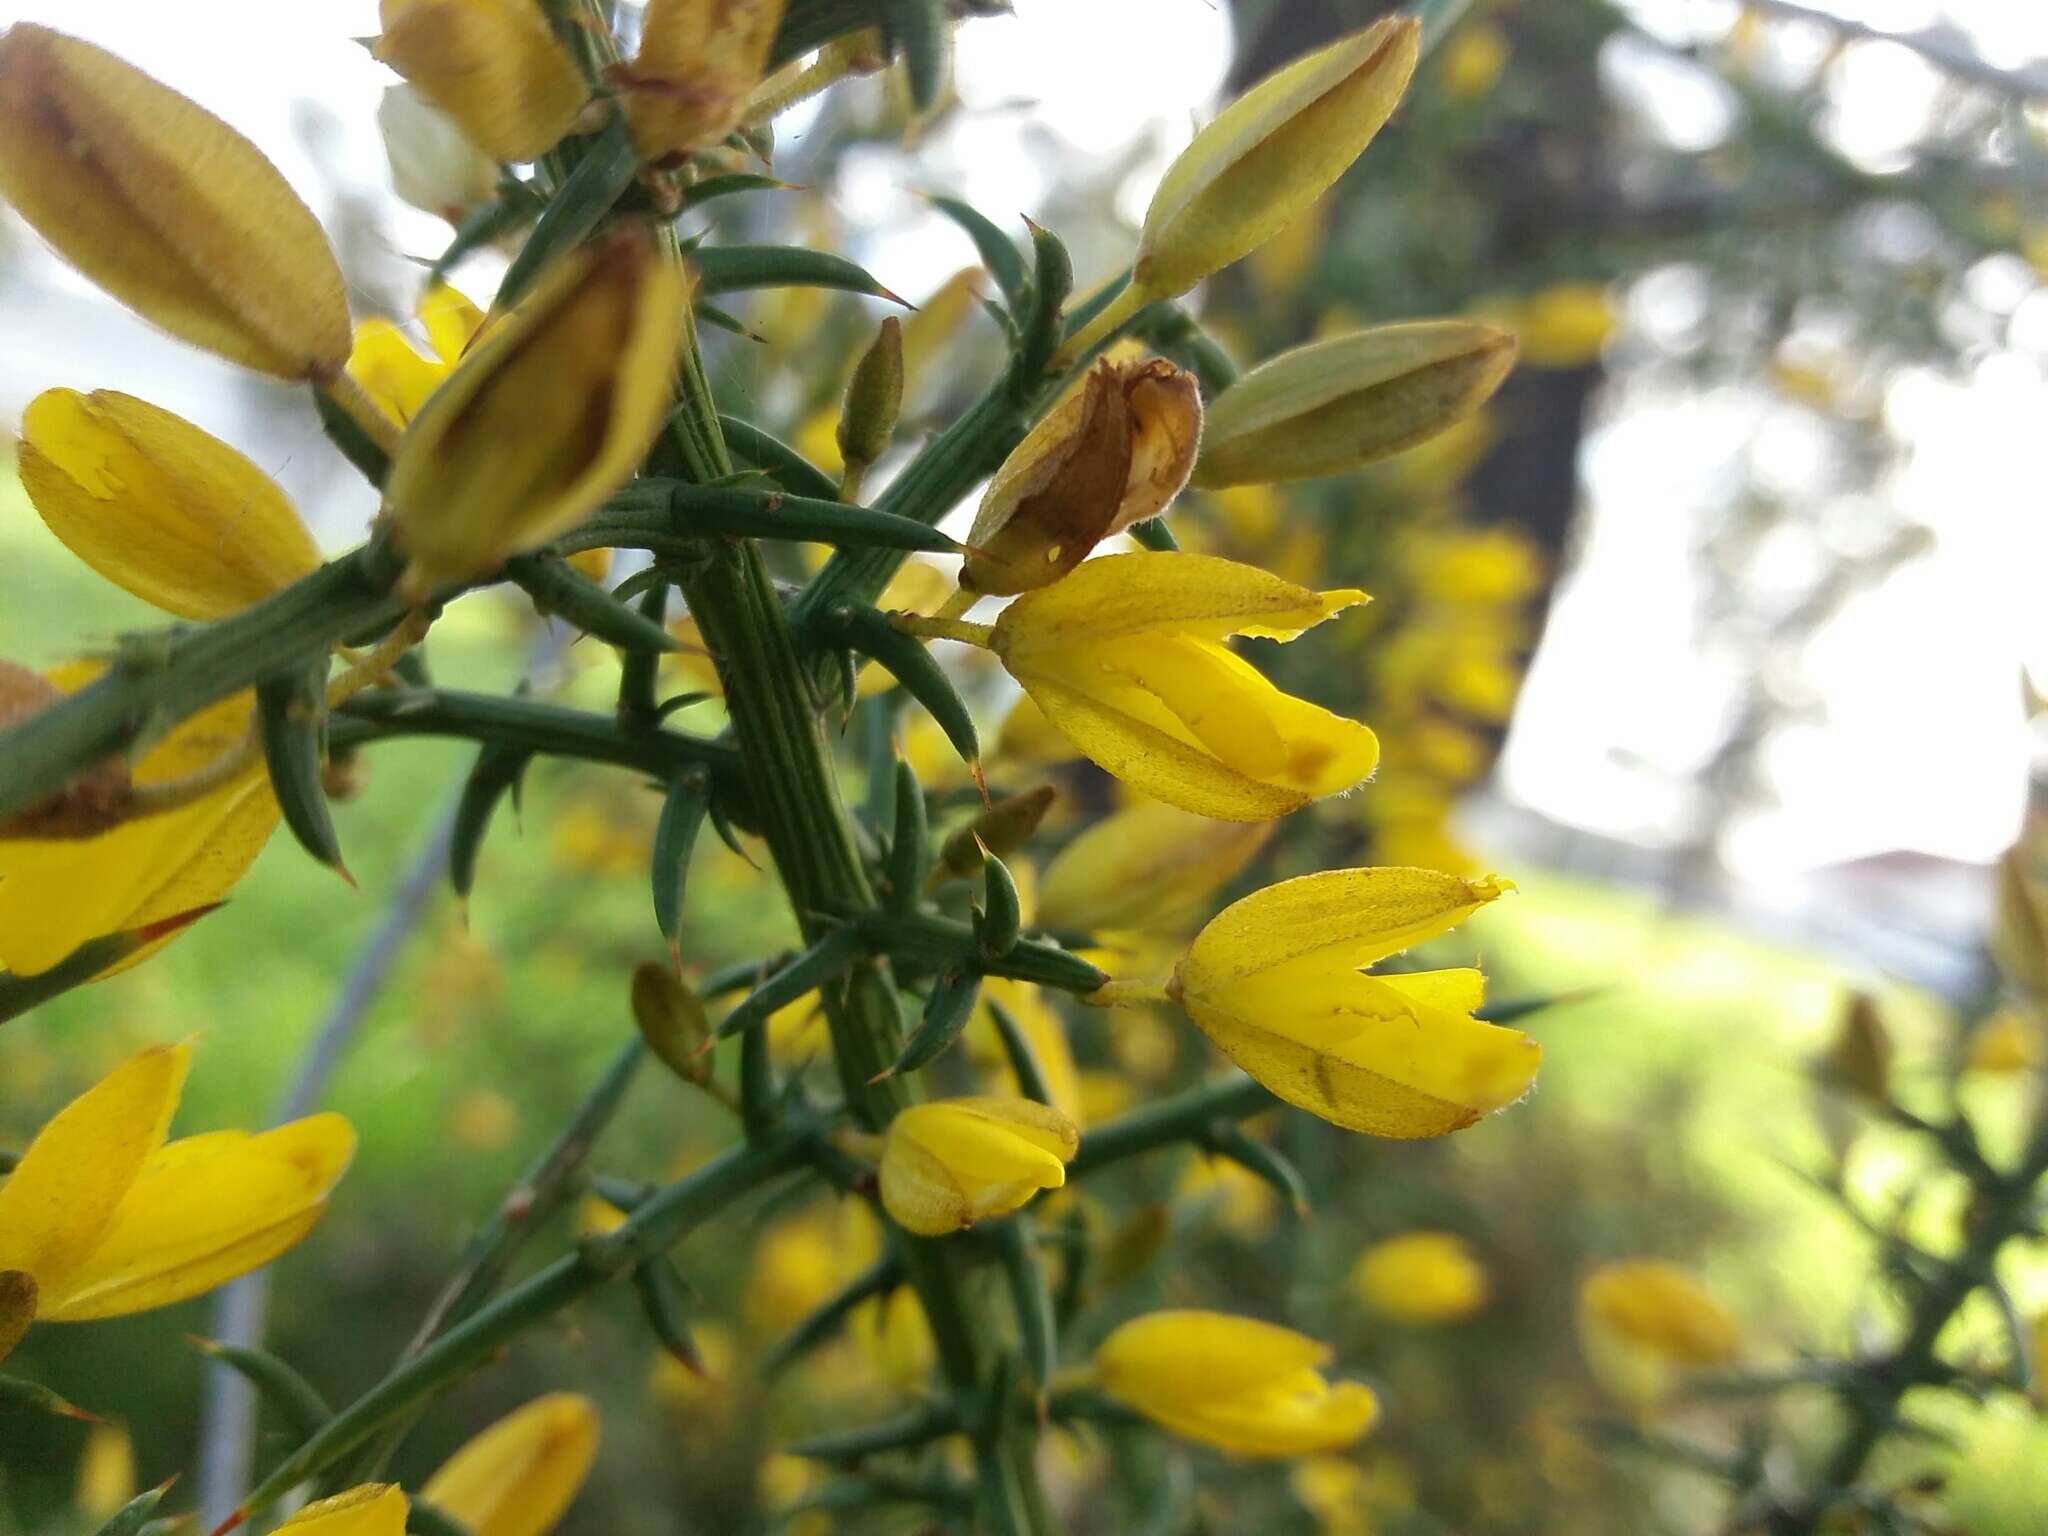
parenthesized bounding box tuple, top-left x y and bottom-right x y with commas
(371, 0, 590, 160)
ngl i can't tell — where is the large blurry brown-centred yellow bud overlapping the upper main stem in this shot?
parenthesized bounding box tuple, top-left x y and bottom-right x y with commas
(385, 229, 686, 596)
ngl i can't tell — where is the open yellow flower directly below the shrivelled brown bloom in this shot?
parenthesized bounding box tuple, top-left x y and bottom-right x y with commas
(989, 553, 1380, 821)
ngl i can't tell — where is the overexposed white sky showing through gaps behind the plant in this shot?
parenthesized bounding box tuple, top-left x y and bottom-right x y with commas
(0, 0, 2048, 887)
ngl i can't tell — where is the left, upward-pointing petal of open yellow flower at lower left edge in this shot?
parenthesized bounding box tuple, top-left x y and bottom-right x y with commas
(0, 1044, 193, 1307)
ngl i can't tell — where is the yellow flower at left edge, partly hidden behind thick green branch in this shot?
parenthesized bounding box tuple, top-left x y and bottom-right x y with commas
(0, 662, 279, 975)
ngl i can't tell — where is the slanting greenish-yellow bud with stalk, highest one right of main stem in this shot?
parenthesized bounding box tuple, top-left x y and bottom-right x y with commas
(1065, 16, 1421, 356)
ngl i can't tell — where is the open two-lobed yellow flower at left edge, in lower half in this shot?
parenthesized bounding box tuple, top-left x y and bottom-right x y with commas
(0, 1044, 356, 1359)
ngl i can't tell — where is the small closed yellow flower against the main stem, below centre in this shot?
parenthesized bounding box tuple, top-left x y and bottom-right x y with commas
(881, 1098, 1081, 1237)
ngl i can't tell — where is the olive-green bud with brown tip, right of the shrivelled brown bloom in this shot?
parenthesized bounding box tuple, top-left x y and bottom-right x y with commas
(1194, 319, 1516, 489)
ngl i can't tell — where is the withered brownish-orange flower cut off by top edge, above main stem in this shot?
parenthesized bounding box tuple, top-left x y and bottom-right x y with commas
(616, 0, 782, 166)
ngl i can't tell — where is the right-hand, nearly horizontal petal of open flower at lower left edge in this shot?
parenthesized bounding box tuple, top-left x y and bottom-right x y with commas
(43, 1114, 356, 1323)
